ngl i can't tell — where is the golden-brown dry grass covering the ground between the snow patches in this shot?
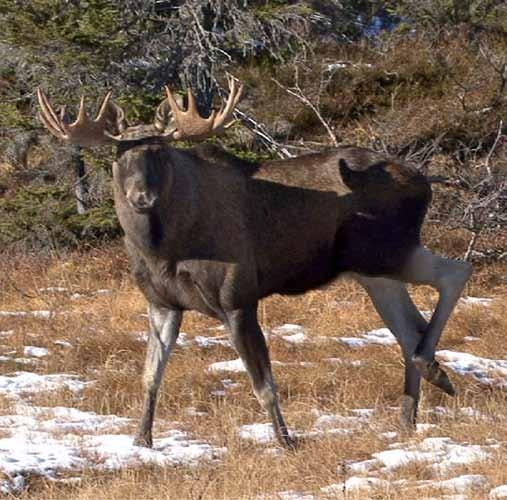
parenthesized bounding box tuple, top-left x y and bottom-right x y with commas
(0, 246, 507, 500)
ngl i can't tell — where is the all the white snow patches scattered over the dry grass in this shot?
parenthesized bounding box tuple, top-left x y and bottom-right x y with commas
(0, 287, 507, 500)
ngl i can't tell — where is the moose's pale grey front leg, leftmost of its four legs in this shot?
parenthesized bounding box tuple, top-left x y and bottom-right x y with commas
(134, 304, 183, 447)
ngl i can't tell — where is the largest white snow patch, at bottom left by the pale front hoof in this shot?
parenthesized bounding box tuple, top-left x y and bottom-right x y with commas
(0, 405, 225, 488)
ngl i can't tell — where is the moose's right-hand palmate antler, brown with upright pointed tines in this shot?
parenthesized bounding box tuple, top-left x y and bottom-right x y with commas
(165, 77, 243, 139)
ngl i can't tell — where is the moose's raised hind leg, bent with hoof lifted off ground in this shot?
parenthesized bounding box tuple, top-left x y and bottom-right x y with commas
(401, 247, 472, 395)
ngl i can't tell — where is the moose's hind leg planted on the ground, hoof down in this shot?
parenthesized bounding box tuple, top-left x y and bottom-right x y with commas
(357, 276, 428, 429)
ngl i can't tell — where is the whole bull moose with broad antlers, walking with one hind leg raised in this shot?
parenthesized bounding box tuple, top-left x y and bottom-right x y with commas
(37, 79, 471, 446)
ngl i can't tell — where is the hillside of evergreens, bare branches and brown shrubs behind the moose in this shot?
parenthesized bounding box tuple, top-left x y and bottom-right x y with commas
(0, 0, 507, 263)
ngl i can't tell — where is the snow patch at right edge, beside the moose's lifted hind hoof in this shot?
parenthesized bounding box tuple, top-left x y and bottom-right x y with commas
(436, 350, 507, 387)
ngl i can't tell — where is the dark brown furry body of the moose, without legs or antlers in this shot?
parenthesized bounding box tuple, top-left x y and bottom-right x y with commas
(115, 144, 431, 319)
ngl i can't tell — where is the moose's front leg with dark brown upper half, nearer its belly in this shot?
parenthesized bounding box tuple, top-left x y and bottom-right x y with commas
(227, 306, 293, 447)
